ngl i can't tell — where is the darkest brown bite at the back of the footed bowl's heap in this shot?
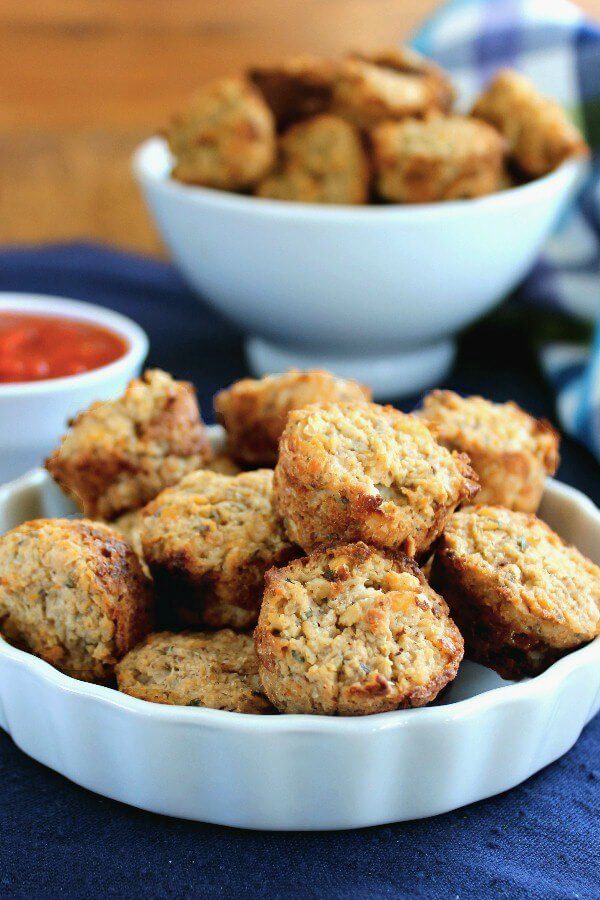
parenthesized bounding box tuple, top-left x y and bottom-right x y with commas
(248, 54, 336, 129)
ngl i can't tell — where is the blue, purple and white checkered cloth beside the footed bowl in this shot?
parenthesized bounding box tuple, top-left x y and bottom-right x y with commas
(412, 0, 600, 459)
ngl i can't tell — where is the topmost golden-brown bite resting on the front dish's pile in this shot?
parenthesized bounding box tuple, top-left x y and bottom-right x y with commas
(274, 403, 478, 556)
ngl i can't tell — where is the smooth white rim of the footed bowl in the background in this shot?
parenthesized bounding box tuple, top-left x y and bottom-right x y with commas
(131, 137, 589, 222)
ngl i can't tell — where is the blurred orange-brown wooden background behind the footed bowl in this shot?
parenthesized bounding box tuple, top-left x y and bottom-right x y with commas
(0, 0, 600, 252)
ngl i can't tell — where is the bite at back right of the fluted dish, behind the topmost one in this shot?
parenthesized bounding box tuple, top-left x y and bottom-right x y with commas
(416, 391, 559, 512)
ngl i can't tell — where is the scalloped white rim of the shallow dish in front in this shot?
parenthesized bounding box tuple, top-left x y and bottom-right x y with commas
(0, 464, 600, 734)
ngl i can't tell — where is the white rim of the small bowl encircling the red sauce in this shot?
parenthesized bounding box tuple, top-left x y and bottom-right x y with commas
(0, 291, 150, 400)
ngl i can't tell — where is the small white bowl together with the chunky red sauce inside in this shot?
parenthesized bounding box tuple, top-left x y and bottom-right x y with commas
(0, 293, 148, 481)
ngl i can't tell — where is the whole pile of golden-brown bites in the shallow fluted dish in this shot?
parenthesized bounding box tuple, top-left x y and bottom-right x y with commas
(0, 370, 600, 715)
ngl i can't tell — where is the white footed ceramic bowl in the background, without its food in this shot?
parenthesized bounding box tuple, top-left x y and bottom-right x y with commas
(133, 138, 582, 396)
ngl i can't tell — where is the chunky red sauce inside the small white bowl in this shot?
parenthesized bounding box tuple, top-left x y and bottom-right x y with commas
(0, 311, 128, 383)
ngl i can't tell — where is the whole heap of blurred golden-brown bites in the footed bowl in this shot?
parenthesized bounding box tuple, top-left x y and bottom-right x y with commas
(164, 48, 587, 204)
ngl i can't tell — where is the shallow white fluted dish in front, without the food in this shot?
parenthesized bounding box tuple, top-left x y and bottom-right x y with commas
(0, 429, 600, 830)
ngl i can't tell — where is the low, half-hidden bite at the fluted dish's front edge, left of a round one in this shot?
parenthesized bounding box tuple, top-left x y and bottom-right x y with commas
(116, 629, 274, 713)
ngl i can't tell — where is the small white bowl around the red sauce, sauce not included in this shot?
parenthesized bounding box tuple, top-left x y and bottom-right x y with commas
(0, 293, 148, 482)
